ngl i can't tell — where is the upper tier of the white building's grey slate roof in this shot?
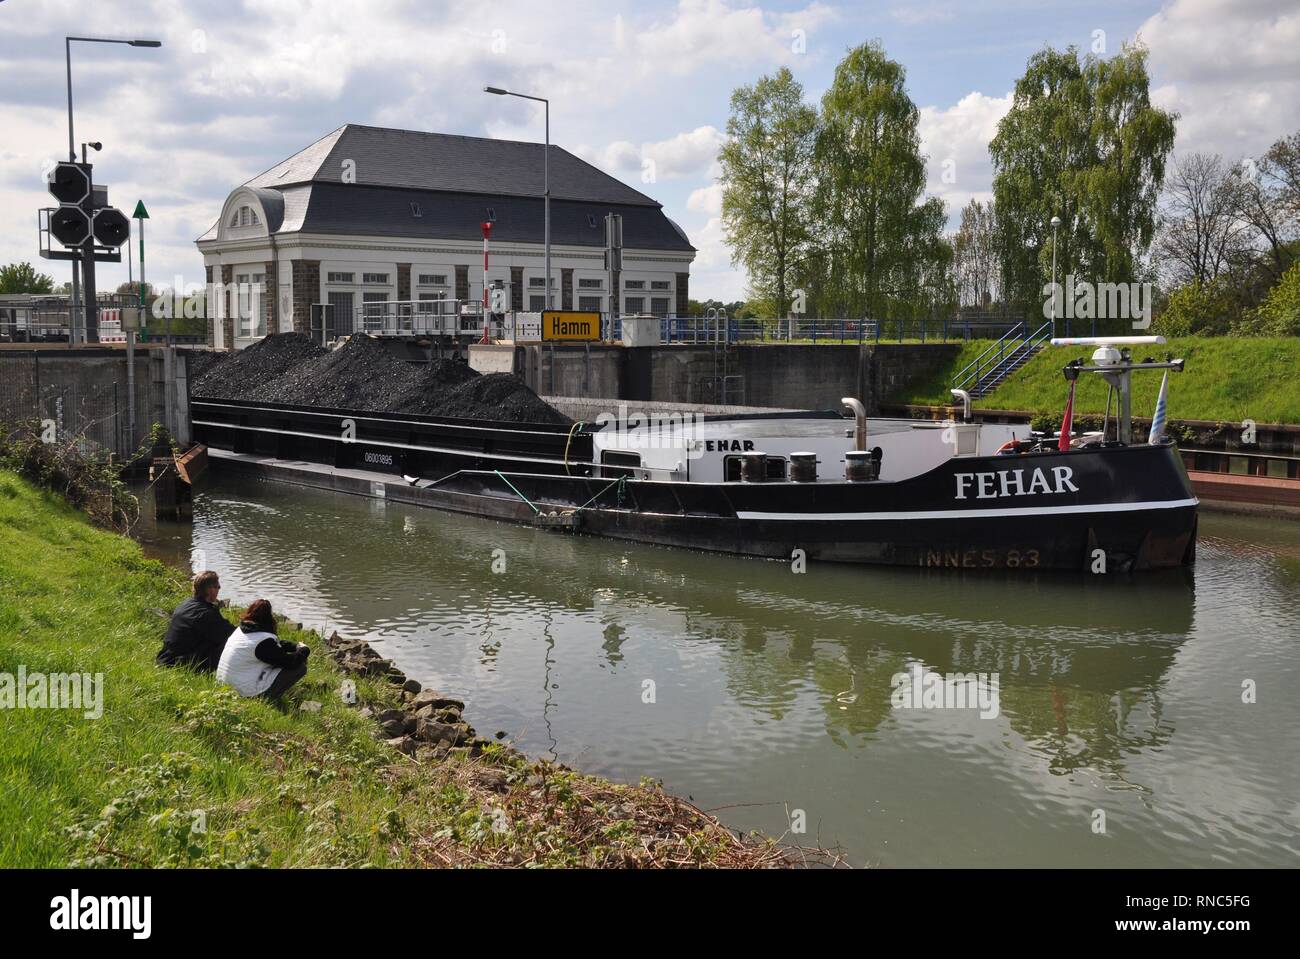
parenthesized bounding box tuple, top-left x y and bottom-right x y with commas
(246, 123, 658, 207)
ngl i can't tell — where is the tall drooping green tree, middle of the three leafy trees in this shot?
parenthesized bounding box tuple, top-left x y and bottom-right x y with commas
(816, 42, 952, 318)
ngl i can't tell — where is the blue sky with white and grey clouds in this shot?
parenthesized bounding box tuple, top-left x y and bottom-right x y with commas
(0, 0, 1300, 301)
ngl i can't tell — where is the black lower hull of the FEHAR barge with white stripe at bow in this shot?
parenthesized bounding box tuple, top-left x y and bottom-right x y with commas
(205, 436, 1196, 573)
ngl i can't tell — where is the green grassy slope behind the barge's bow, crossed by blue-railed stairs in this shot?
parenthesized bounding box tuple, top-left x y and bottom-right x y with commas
(888, 337, 1300, 424)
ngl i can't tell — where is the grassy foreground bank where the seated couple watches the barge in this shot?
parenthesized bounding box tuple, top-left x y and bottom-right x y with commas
(0, 472, 811, 868)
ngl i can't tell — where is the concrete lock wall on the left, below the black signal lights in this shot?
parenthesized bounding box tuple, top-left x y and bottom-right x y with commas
(0, 347, 190, 456)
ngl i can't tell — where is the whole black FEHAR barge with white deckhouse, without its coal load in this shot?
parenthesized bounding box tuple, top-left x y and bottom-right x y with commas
(192, 338, 1196, 572)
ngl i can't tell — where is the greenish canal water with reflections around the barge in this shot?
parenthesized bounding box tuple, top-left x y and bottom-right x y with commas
(148, 477, 1300, 867)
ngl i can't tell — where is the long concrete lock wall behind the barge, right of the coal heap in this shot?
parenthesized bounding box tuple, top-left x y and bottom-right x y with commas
(496, 343, 958, 416)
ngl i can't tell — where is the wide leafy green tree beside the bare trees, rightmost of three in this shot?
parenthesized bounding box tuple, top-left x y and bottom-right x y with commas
(989, 45, 1177, 314)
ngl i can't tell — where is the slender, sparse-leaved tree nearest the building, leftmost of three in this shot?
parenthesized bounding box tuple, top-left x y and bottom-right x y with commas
(718, 68, 816, 316)
